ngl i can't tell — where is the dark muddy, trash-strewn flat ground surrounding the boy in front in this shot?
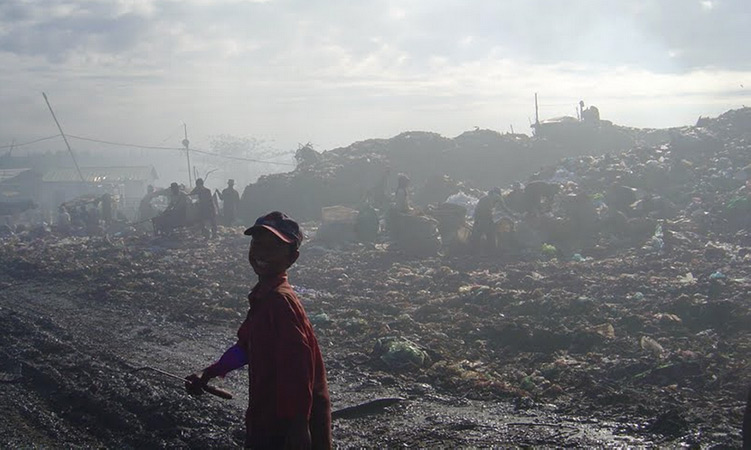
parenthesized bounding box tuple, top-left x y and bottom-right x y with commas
(0, 229, 751, 448)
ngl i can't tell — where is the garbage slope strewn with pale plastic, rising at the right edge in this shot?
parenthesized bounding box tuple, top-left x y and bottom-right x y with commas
(531, 108, 751, 246)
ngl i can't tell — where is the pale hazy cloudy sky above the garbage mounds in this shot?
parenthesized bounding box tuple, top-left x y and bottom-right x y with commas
(0, 0, 751, 156)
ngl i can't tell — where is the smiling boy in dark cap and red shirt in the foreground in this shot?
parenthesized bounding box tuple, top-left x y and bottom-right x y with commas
(185, 211, 332, 449)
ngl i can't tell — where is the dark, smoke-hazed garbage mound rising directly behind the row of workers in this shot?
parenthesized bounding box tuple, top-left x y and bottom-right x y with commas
(240, 121, 652, 220)
